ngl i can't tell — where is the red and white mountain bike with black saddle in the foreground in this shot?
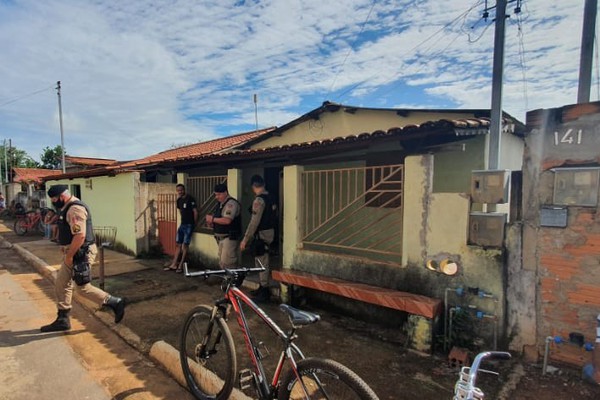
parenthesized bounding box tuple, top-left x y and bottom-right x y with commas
(179, 263, 378, 400)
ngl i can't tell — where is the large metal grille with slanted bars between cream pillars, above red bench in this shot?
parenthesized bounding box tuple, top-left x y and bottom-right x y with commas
(301, 165, 404, 264)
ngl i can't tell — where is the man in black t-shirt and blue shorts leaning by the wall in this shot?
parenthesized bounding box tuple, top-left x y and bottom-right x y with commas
(164, 183, 198, 273)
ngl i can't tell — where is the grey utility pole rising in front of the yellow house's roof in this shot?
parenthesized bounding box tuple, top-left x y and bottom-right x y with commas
(486, 0, 507, 170)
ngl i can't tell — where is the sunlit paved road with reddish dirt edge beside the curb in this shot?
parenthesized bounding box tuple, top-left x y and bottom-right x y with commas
(0, 234, 191, 400)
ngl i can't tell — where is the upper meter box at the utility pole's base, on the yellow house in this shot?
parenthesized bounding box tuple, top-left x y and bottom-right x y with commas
(471, 169, 510, 204)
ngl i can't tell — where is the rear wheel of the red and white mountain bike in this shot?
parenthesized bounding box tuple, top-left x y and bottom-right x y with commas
(278, 358, 378, 400)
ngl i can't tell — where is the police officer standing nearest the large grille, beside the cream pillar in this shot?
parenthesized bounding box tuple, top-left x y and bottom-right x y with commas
(240, 175, 276, 301)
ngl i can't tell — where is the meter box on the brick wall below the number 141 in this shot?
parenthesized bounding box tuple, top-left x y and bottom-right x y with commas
(552, 167, 600, 207)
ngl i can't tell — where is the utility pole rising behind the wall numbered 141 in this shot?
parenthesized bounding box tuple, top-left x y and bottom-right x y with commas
(577, 0, 598, 103)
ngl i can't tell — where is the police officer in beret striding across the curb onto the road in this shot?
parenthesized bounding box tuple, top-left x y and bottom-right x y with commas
(40, 185, 125, 332)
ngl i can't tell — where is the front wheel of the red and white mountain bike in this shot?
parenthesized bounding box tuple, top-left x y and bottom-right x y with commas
(179, 305, 237, 400)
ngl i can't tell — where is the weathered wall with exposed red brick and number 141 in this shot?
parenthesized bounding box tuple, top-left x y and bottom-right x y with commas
(508, 102, 600, 366)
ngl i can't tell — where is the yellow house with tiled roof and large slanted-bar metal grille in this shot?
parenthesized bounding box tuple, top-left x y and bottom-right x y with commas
(158, 103, 524, 345)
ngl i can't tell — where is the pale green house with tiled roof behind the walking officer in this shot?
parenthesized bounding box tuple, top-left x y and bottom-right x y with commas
(46, 128, 272, 254)
